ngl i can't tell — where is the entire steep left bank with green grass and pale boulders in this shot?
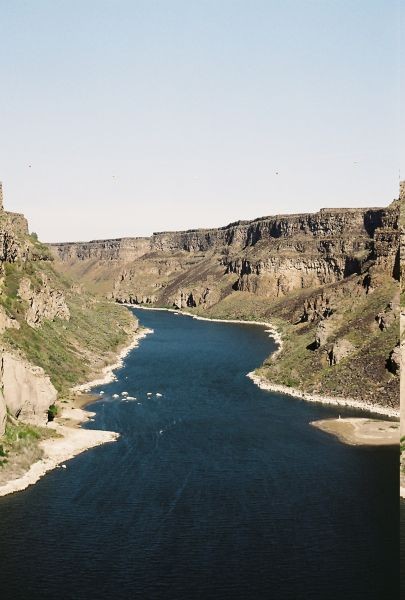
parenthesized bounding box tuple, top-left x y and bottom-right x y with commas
(0, 184, 137, 440)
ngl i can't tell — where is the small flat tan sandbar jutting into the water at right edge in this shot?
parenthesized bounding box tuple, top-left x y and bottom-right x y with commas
(311, 418, 399, 446)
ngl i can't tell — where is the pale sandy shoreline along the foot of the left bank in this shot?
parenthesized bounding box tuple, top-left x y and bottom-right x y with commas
(0, 329, 152, 497)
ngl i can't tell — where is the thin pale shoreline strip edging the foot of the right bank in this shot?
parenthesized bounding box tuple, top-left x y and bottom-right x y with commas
(129, 304, 399, 419)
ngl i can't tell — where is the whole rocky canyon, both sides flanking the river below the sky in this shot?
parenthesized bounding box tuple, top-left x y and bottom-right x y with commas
(0, 178, 404, 435)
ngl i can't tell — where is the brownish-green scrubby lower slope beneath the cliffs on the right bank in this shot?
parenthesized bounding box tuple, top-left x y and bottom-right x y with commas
(185, 278, 399, 408)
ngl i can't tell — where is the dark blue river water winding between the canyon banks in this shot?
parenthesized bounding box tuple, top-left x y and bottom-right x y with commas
(0, 310, 399, 600)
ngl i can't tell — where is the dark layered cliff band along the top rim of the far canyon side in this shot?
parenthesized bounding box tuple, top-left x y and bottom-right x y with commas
(49, 208, 389, 262)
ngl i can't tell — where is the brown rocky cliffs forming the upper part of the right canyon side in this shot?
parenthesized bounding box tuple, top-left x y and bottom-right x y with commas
(50, 208, 399, 318)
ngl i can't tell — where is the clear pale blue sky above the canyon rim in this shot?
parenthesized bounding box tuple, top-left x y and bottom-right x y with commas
(0, 0, 404, 241)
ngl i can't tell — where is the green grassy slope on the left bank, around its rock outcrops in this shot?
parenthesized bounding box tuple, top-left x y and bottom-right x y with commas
(0, 251, 136, 395)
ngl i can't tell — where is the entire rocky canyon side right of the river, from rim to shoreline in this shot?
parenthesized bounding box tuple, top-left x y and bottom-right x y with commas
(51, 188, 399, 409)
